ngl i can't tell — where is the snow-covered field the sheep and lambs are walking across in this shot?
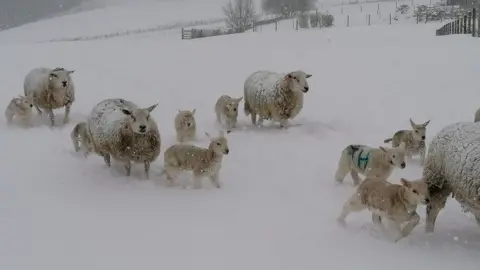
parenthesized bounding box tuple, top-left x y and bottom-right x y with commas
(0, 0, 480, 270)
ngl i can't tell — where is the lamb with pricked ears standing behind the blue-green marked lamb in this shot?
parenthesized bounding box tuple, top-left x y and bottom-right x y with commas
(383, 118, 430, 166)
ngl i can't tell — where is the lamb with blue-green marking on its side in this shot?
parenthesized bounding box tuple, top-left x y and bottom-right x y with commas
(335, 142, 406, 186)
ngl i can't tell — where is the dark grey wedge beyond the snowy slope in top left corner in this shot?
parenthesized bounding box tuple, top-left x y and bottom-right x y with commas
(0, 0, 84, 29)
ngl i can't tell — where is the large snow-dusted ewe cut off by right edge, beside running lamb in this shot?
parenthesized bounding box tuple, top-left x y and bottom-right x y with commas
(423, 122, 480, 232)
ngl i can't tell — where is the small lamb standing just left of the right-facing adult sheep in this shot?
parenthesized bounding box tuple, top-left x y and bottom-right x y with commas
(215, 95, 243, 133)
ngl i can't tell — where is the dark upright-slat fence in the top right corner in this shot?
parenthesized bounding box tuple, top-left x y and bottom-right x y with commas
(436, 8, 480, 37)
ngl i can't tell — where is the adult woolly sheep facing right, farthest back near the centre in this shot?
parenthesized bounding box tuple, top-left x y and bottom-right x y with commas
(244, 70, 312, 128)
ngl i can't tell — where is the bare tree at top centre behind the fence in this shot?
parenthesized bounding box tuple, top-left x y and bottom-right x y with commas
(222, 0, 255, 32)
